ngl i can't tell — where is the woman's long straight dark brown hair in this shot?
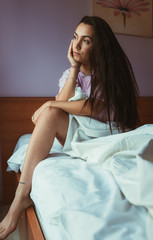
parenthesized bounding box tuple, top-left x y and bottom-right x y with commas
(80, 16, 139, 131)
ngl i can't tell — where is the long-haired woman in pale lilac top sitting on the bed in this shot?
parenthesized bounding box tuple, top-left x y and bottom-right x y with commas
(0, 16, 138, 239)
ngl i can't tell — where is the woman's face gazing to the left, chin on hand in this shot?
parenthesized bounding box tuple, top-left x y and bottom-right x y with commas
(72, 23, 94, 65)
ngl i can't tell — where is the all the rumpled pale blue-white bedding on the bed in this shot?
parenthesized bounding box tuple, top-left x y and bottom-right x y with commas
(8, 123, 153, 240)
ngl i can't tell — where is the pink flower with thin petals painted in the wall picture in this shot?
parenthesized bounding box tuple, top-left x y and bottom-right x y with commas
(96, 0, 150, 26)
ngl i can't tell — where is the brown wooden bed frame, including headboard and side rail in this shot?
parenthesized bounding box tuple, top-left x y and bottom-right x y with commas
(0, 97, 153, 240)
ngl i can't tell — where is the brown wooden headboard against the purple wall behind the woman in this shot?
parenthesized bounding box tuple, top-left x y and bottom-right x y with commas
(0, 97, 153, 203)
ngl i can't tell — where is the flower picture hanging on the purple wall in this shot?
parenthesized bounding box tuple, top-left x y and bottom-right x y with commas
(92, 0, 153, 37)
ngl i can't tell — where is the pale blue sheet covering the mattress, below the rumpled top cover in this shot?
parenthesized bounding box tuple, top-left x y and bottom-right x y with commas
(9, 135, 148, 240)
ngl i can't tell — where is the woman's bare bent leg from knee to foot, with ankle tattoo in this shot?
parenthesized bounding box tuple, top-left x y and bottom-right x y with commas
(0, 108, 69, 239)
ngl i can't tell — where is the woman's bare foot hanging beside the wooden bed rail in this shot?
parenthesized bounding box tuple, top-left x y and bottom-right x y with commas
(0, 194, 33, 239)
